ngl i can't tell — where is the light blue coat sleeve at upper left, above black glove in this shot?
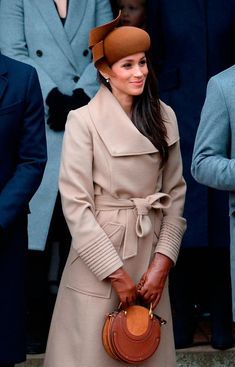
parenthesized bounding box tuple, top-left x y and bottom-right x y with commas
(0, 0, 56, 99)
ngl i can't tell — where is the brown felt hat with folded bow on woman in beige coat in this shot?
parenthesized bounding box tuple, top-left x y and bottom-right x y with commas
(89, 12, 150, 75)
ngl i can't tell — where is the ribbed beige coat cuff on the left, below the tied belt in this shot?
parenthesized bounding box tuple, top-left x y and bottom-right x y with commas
(79, 235, 123, 280)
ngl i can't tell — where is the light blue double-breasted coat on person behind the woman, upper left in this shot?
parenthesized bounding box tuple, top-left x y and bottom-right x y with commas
(0, 0, 112, 250)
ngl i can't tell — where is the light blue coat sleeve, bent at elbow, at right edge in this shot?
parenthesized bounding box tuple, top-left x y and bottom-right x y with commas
(191, 78, 235, 191)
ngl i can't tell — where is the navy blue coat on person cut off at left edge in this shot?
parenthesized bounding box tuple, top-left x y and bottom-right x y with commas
(0, 54, 47, 364)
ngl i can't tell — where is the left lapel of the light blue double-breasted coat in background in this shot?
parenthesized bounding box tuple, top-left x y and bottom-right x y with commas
(32, 0, 76, 68)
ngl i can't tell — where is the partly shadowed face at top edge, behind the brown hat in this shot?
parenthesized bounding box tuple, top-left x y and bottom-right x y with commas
(119, 0, 145, 27)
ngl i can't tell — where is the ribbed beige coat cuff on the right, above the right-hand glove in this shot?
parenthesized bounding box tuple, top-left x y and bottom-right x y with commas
(155, 216, 186, 264)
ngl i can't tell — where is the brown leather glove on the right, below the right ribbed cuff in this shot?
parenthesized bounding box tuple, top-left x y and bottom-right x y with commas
(137, 253, 173, 309)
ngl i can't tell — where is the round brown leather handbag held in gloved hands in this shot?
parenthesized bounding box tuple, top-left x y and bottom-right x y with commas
(102, 305, 166, 364)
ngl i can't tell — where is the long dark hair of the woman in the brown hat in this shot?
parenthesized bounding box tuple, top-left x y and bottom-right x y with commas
(98, 56, 168, 166)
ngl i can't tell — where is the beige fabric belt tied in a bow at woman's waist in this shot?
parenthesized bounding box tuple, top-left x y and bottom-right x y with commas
(95, 192, 171, 260)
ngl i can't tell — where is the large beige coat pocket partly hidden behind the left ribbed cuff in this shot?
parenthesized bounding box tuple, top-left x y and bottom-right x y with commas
(67, 223, 125, 298)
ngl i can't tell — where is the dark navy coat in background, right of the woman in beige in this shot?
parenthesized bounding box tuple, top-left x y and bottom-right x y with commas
(148, 0, 235, 247)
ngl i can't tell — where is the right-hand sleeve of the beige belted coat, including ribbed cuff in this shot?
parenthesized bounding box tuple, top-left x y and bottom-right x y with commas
(155, 107, 186, 263)
